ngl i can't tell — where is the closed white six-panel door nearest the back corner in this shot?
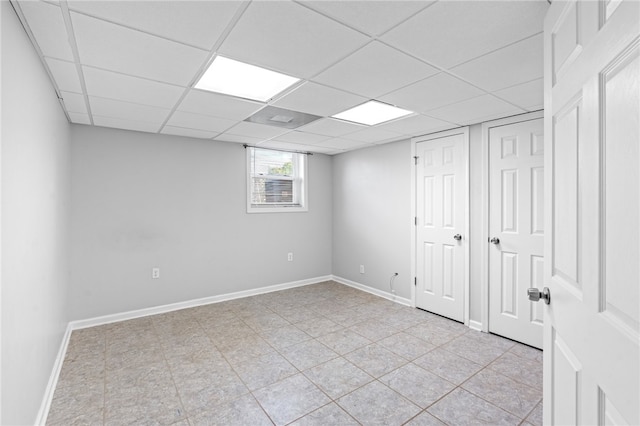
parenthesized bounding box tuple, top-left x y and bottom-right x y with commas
(416, 129, 468, 322)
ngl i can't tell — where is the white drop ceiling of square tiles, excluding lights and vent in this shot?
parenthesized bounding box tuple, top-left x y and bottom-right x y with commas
(12, 0, 548, 154)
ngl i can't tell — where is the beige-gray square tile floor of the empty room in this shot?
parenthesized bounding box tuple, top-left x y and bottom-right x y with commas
(47, 282, 542, 426)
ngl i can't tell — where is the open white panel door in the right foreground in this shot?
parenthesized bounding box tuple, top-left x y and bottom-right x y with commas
(544, 0, 640, 425)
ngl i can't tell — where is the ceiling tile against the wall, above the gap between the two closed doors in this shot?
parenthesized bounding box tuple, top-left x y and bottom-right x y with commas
(429, 95, 525, 125)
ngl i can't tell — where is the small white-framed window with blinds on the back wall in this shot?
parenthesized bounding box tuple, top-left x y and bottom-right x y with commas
(247, 147, 307, 213)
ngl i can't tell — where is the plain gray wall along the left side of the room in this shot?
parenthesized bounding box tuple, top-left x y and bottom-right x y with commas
(0, 1, 70, 425)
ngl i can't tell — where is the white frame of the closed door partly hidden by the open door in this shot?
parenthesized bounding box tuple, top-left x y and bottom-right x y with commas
(480, 110, 544, 333)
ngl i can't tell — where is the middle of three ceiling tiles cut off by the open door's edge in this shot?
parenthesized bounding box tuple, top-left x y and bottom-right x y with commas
(451, 34, 544, 92)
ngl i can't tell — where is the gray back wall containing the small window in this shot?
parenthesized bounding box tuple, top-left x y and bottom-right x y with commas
(69, 125, 332, 320)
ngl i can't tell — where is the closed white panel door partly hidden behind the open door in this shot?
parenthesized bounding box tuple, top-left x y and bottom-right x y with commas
(489, 118, 544, 348)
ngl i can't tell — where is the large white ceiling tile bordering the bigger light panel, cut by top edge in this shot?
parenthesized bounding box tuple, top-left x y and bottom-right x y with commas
(220, 1, 368, 78)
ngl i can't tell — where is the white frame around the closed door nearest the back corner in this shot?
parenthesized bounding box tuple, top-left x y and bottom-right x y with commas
(409, 126, 471, 326)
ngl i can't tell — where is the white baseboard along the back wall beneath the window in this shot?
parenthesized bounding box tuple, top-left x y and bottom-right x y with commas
(69, 275, 332, 330)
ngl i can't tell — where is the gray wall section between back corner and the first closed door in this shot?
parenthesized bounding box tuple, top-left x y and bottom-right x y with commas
(333, 140, 412, 299)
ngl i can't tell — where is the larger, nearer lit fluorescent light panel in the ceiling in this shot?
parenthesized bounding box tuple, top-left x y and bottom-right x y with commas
(195, 56, 300, 102)
